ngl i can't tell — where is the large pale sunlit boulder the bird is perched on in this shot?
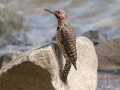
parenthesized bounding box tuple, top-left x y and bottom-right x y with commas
(0, 37, 98, 90)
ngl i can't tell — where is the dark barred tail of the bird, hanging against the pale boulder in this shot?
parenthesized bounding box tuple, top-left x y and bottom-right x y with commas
(61, 60, 71, 84)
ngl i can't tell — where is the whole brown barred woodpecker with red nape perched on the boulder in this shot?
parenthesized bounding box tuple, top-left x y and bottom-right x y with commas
(45, 9, 77, 83)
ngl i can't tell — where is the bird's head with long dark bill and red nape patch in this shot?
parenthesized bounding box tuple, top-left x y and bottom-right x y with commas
(45, 9, 68, 20)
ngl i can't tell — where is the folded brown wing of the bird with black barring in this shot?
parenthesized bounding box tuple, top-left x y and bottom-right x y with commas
(61, 27, 77, 62)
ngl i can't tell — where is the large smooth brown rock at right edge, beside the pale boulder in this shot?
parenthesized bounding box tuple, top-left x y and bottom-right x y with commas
(95, 39, 120, 70)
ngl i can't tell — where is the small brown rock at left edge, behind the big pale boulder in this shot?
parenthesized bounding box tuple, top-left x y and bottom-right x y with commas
(0, 53, 18, 68)
